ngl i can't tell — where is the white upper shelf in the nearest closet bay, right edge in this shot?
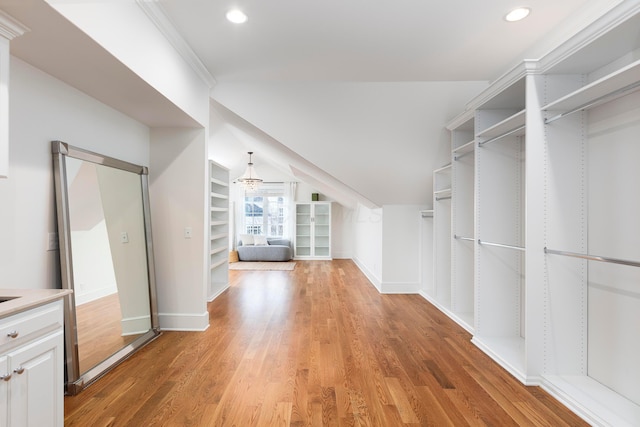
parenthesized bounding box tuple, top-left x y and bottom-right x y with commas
(542, 60, 640, 123)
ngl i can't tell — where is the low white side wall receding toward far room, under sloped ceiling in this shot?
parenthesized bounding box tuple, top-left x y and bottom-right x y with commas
(352, 205, 383, 290)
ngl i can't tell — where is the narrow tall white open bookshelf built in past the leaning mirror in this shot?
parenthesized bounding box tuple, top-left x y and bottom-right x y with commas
(209, 160, 229, 296)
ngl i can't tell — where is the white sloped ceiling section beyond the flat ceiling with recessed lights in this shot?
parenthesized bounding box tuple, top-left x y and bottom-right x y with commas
(212, 82, 487, 206)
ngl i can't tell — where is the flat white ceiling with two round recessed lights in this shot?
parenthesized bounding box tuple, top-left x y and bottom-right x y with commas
(158, 0, 613, 82)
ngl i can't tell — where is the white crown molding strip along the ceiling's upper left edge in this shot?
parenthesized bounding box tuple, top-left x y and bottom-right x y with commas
(136, 0, 216, 88)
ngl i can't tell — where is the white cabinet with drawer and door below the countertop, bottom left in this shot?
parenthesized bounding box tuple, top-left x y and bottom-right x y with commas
(0, 300, 64, 427)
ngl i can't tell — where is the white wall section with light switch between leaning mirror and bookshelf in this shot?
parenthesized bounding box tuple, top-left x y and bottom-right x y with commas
(149, 129, 209, 330)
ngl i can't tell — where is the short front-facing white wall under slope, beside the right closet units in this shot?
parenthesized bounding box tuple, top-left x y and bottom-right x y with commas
(381, 205, 425, 293)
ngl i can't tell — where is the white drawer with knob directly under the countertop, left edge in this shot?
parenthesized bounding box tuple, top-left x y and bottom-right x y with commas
(0, 301, 64, 350)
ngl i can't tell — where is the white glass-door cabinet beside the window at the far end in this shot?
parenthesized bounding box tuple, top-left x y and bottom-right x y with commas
(294, 202, 331, 259)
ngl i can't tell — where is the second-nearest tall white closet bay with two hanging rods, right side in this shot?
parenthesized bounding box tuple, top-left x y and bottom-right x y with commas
(473, 75, 527, 381)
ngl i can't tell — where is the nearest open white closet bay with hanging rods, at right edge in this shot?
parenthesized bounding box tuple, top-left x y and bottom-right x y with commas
(535, 7, 640, 426)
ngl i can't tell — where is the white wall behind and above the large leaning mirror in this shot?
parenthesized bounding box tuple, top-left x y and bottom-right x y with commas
(0, 57, 149, 289)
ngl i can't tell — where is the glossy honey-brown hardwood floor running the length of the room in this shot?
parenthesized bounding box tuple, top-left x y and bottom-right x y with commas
(65, 260, 586, 427)
